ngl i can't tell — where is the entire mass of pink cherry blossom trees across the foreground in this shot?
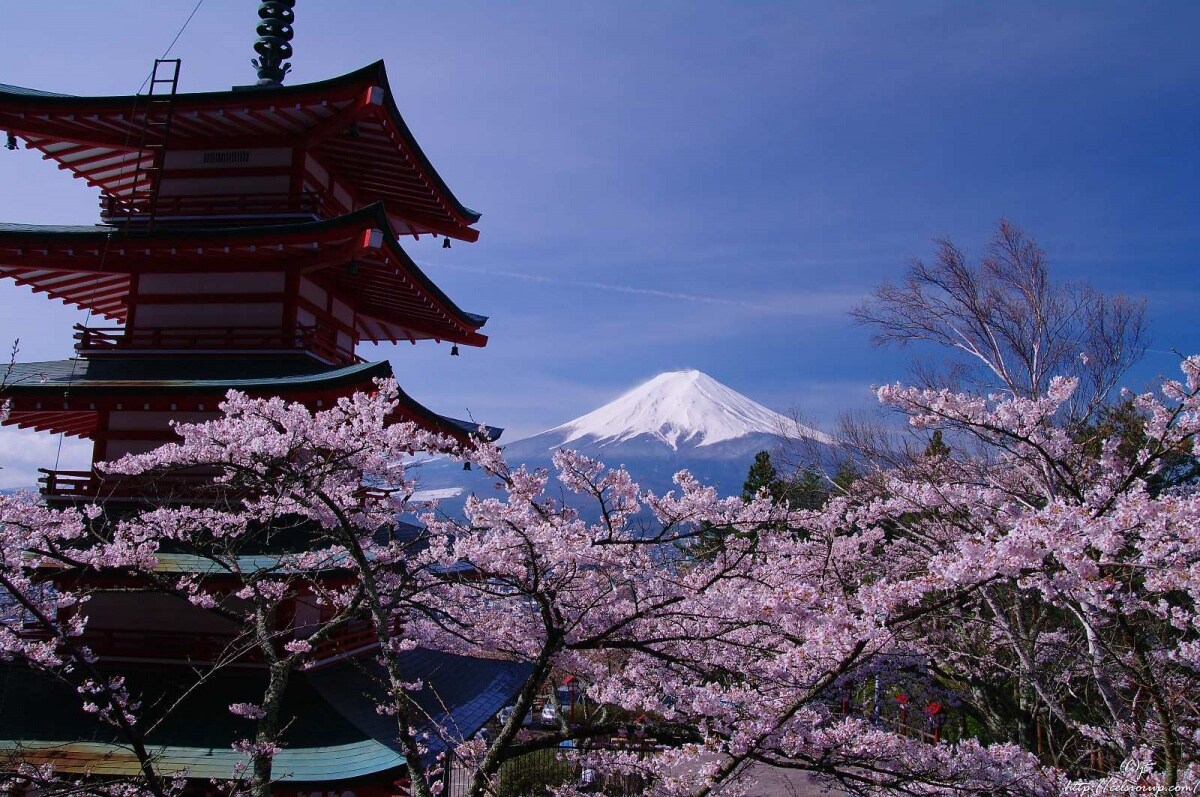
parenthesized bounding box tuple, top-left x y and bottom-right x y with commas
(0, 358, 1200, 796)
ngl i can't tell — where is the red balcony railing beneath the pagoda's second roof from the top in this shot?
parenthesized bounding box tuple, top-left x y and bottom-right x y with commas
(74, 324, 364, 364)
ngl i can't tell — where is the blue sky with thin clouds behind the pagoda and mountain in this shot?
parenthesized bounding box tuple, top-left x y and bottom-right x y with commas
(0, 0, 1200, 480)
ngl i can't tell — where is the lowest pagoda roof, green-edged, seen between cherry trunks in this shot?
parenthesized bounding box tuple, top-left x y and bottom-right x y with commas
(0, 648, 530, 783)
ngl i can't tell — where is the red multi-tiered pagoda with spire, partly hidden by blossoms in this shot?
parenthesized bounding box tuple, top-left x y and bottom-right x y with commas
(0, 0, 521, 796)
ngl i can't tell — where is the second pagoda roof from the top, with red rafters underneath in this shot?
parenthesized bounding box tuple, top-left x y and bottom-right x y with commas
(0, 203, 487, 346)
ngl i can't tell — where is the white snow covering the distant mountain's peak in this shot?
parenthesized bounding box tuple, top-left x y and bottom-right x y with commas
(546, 370, 832, 449)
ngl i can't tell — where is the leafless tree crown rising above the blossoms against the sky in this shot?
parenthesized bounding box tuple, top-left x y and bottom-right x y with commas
(851, 220, 1147, 423)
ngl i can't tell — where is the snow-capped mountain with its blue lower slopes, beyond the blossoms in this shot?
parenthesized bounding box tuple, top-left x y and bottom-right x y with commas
(416, 370, 832, 509)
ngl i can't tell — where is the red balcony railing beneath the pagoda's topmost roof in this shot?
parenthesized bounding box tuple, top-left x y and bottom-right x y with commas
(100, 192, 344, 224)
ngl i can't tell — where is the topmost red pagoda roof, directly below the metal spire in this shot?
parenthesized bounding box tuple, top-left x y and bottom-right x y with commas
(0, 61, 480, 241)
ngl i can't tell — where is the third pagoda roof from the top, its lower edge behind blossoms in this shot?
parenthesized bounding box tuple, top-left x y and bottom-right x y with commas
(5, 356, 503, 439)
